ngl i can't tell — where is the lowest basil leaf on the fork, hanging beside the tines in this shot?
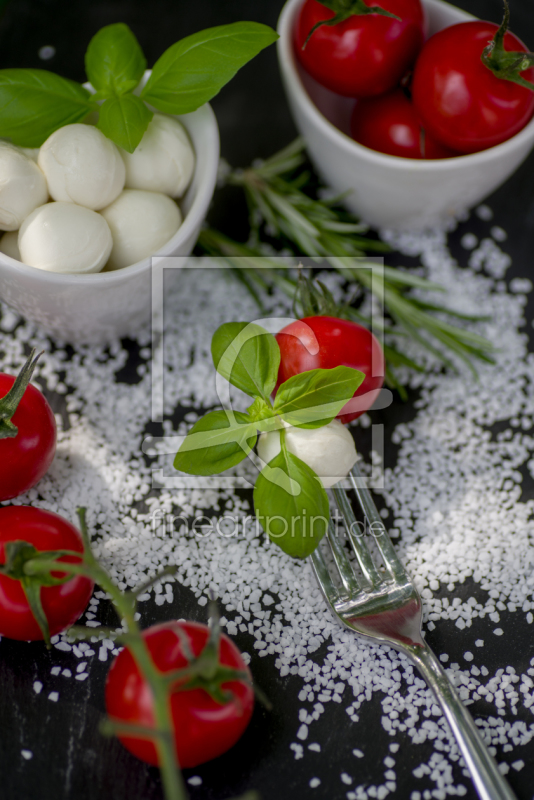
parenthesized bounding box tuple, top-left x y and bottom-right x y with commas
(254, 450, 330, 558)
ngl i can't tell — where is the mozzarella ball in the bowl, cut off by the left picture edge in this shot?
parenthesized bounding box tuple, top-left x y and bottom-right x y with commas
(0, 142, 48, 231)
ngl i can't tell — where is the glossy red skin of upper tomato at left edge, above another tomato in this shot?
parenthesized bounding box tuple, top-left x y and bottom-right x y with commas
(0, 373, 57, 501)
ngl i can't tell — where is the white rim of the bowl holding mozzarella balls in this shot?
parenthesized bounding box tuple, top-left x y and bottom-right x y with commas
(0, 103, 219, 288)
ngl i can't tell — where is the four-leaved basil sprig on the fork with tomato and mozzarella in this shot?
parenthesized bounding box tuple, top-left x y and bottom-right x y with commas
(174, 322, 365, 558)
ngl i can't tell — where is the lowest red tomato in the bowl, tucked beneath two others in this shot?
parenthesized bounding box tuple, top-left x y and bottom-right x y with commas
(351, 89, 458, 159)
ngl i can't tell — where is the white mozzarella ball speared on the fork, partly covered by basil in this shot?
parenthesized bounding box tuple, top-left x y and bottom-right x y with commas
(258, 419, 358, 489)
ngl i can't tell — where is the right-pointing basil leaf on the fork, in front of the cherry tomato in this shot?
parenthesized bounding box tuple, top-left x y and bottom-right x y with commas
(274, 367, 365, 428)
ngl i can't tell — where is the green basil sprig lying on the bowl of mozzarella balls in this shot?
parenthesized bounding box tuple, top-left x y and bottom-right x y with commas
(0, 22, 278, 153)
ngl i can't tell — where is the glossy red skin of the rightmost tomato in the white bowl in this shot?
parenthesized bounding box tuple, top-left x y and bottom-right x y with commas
(412, 21, 534, 154)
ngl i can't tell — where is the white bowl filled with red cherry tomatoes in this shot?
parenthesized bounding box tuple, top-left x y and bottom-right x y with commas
(278, 0, 534, 230)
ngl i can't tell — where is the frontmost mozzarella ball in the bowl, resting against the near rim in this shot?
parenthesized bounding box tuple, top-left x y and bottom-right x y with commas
(19, 202, 113, 274)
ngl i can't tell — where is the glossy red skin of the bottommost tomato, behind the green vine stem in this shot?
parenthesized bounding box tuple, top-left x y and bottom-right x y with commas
(106, 622, 254, 768)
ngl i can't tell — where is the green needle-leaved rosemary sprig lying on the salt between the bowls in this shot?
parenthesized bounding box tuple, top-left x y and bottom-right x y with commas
(199, 139, 494, 394)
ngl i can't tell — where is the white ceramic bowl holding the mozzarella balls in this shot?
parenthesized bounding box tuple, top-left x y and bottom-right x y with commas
(0, 76, 219, 343)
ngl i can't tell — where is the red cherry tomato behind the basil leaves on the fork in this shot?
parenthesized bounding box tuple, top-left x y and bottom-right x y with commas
(276, 317, 385, 422)
